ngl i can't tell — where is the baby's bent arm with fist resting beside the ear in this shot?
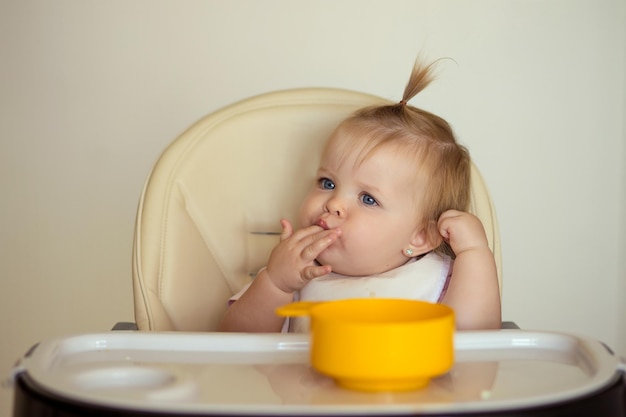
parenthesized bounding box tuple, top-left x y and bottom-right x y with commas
(439, 210, 501, 330)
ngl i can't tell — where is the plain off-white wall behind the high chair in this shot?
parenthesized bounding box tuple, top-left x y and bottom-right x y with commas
(0, 0, 626, 415)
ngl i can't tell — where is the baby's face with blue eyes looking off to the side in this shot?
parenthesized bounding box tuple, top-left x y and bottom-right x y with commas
(299, 135, 429, 276)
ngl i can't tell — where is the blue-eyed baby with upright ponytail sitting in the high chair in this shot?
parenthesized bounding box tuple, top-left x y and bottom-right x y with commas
(220, 62, 501, 332)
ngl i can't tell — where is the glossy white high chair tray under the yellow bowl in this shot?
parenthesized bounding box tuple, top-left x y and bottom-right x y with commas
(13, 330, 624, 417)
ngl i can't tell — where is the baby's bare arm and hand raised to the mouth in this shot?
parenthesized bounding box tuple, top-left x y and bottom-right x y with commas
(220, 220, 340, 332)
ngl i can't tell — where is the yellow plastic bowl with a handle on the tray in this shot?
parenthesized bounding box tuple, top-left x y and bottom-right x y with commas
(277, 298, 454, 391)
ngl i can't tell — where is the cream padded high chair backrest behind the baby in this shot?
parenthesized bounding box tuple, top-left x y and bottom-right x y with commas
(133, 89, 500, 331)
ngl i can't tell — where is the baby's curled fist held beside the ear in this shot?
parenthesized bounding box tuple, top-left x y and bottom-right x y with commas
(438, 210, 489, 256)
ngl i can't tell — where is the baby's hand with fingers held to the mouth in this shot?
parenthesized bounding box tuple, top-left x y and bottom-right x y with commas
(266, 219, 340, 293)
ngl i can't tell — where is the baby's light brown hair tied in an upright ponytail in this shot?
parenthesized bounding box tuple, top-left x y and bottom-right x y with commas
(326, 57, 471, 257)
